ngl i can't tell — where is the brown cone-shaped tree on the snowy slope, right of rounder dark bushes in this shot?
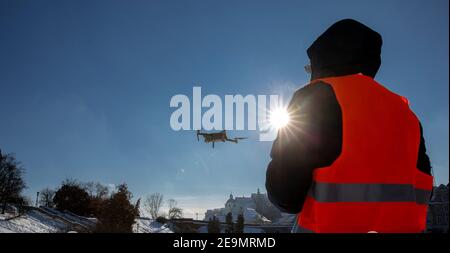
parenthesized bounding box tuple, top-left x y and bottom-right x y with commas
(95, 184, 138, 233)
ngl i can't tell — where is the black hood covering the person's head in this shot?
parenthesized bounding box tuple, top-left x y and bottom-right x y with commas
(307, 19, 383, 79)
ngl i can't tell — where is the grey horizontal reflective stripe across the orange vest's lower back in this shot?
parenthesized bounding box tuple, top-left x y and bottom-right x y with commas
(309, 182, 431, 205)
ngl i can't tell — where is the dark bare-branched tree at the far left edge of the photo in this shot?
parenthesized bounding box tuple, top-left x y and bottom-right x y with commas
(0, 151, 25, 214)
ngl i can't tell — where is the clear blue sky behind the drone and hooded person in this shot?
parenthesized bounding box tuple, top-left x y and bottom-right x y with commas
(0, 0, 449, 216)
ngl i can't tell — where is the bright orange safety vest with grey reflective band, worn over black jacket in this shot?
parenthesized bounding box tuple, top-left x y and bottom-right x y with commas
(297, 74, 433, 233)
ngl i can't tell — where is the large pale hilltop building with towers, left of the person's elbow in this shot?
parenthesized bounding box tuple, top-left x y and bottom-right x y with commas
(204, 189, 281, 224)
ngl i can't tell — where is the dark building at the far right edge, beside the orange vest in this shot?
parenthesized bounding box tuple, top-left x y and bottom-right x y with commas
(427, 184, 448, 233)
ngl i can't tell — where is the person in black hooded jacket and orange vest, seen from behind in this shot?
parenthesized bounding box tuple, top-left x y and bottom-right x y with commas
(266, 19, 433, 233)
